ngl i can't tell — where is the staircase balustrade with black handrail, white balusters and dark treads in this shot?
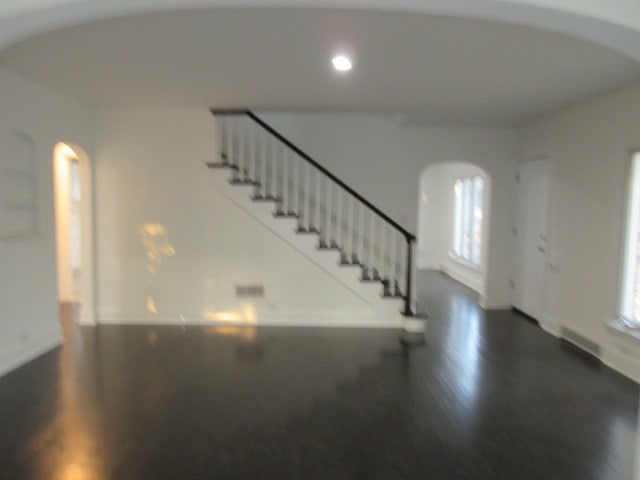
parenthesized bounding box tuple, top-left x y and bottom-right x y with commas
(207, 110, 426, 333)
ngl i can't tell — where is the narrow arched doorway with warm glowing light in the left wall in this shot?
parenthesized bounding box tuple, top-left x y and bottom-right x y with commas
(53, 142, 95, 325)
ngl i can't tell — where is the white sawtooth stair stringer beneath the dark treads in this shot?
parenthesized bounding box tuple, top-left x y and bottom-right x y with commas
(210, 168, 405, 328)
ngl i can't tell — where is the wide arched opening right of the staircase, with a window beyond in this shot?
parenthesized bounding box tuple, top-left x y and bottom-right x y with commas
(416, 162, 491, 304)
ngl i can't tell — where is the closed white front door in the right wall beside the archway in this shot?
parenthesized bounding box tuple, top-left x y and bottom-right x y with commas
(513, 159, 551, 321)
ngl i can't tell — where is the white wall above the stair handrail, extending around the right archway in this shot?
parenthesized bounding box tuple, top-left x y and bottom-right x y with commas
(261, 112, 517, 308)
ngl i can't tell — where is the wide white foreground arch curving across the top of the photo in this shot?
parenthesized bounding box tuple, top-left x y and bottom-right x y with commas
(0, 0, 640, 61)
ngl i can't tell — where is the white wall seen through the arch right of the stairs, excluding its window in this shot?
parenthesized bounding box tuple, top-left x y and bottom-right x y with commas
(417, 163, 491, 299)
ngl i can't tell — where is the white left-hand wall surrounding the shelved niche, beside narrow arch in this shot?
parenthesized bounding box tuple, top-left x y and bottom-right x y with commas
(0, 70, 93, 374)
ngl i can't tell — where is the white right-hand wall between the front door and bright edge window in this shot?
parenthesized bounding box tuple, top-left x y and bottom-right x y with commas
(522, 81, 640, 379)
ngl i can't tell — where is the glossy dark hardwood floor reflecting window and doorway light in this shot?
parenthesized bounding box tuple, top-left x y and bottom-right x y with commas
(0, 273, 638, 480)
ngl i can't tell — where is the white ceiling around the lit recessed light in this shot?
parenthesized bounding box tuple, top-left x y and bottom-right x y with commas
(0, 8, 640, 124)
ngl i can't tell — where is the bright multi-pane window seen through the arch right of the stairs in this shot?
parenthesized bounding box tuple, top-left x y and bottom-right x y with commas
(451, 176, 484, 266)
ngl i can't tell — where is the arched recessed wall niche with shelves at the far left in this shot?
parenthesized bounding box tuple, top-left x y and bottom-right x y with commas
(0, 131, 39, 239)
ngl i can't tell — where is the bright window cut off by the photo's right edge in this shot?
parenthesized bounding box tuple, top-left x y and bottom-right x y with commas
(620, 153, 640, 328)
